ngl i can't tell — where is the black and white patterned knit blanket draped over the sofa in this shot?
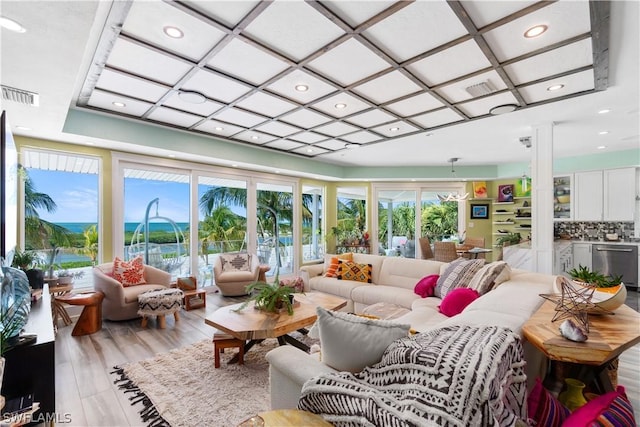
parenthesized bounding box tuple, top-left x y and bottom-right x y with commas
(298, 326, 527, 427)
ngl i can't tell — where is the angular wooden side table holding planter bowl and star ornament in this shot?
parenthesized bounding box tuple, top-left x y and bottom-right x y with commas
(522, 301, 640, 392)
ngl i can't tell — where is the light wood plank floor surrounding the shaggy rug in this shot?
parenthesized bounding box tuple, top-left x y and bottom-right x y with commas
(56, 292, 640, 426)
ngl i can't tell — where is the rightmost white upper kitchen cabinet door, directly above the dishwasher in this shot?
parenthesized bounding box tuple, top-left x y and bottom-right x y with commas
(604, 168, 636, 221)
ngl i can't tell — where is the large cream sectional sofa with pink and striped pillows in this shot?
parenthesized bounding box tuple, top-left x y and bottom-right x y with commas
(267, 254, 556, 409)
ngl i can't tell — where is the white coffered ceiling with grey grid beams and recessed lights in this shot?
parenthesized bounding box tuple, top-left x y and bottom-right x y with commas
(2, 0, 638, 172)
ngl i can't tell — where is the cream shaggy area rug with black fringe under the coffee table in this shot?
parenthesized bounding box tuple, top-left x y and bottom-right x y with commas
(114, 339, 278, 427)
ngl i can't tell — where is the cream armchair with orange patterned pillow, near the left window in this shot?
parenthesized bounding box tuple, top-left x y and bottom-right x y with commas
(93, 262, 171, 320)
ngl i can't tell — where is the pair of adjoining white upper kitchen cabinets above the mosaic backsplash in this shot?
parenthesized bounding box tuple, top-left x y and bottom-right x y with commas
(573, 168, 636, 221)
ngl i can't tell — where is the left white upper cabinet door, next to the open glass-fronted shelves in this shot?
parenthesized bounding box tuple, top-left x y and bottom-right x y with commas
(573, 171, 604, 221)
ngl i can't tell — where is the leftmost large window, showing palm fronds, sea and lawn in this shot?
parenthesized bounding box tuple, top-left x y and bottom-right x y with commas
(21, 149, 101, 288)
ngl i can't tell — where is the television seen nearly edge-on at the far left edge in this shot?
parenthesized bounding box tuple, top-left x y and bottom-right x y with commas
(0, 111, 18, 265)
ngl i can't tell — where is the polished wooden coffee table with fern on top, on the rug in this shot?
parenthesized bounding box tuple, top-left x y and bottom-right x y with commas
(204, 292, 347, 360)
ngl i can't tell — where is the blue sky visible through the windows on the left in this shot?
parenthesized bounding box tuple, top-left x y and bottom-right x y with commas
(29, 169, 244, 223)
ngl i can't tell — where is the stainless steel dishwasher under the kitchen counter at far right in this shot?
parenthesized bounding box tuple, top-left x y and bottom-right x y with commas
(592, 245, 638, 291)
